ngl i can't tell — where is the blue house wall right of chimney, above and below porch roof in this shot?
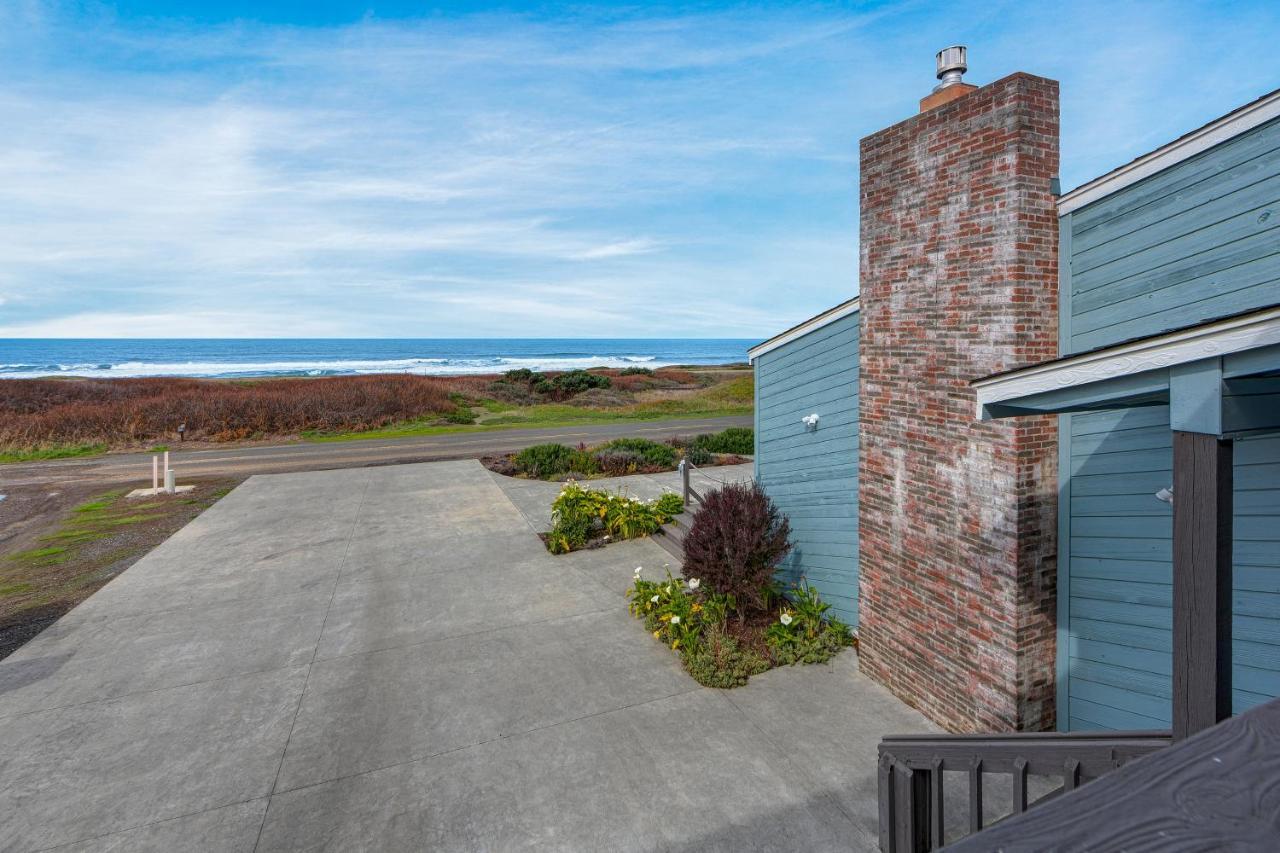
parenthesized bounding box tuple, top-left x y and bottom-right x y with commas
(1059, 112, 1280, 730)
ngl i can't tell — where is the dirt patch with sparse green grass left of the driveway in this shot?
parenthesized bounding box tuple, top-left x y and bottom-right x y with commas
(0, 478, 241, 660)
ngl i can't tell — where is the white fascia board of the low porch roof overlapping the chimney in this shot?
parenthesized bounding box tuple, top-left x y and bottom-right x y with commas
(973, 307, 1280, 418)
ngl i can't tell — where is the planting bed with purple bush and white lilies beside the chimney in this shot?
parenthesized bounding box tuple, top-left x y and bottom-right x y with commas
(628, 484, 854, 688)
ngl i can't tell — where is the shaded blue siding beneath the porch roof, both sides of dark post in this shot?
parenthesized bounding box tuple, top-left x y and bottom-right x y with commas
(1060, 406, 1280, 730)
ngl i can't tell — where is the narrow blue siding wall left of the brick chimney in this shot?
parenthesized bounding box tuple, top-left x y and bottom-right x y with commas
(755, 313, 859, 626)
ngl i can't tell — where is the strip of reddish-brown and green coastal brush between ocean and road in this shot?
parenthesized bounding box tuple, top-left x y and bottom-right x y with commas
(0, 368, 750, 461)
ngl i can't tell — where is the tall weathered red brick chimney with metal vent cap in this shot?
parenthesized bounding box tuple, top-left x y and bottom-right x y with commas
(859, 58, 1059, 731)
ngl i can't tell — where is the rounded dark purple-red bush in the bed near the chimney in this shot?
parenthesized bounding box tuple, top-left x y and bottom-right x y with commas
(684, 483, 791, 617)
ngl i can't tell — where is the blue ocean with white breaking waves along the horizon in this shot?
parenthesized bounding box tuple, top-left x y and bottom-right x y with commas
(0, 338, 758, 379)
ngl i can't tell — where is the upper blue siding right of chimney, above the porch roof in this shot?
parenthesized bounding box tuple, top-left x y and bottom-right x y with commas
(1064, 113, 1280, 355)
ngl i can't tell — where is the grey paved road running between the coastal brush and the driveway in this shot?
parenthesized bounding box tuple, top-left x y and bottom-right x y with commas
(0, 415, 751, 487)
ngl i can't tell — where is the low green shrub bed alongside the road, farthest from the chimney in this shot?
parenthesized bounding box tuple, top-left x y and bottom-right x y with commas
(480, 427, 755, 480)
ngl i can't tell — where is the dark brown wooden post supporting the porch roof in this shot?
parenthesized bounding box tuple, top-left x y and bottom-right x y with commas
(1174, 430, 1231, 740)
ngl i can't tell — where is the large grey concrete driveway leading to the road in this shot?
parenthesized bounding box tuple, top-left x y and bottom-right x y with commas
(0, 461, 927, 850)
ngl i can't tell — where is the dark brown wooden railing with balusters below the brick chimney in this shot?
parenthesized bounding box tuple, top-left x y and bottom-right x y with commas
(879, 731, 1172, 853)
